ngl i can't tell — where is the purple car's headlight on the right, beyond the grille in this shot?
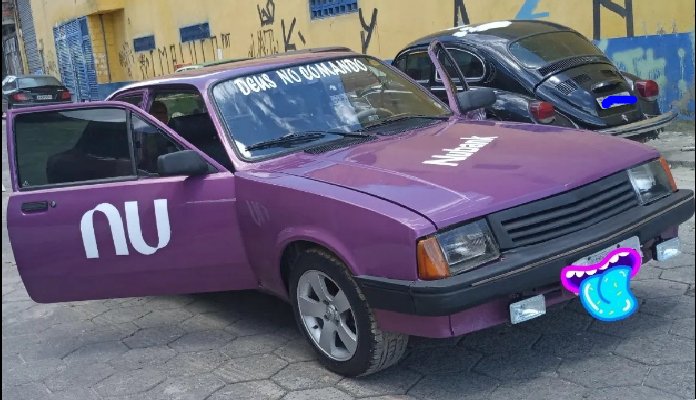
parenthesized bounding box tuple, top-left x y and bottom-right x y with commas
(628, 158, 677, 204)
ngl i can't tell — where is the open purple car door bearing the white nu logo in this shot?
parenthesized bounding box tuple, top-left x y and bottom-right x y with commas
(7, 102, 257, 303)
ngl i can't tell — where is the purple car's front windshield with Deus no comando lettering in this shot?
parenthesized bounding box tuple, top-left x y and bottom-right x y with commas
(213, 56, 451, 158)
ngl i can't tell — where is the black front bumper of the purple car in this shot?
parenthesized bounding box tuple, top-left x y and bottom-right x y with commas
(356, 190, 695, 317)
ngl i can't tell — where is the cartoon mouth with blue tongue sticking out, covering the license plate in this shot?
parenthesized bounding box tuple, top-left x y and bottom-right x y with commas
(561, 248, 642, 321)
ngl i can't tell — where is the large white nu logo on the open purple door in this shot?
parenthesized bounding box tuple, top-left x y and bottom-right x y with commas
(80, 199, 172, 258)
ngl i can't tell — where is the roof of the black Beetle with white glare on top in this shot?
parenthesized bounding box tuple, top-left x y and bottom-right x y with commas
(407, 20, 572, 47)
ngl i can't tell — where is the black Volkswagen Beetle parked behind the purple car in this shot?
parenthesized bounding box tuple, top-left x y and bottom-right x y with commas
(392, 21, 677, 141)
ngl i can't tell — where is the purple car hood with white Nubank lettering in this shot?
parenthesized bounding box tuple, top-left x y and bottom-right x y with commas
(262, 120, 659, 229)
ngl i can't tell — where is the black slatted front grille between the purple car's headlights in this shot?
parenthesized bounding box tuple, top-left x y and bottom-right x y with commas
(488, 172, 638, 250)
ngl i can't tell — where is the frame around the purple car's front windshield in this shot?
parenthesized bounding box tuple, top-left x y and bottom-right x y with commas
(206, 53, 455, 163)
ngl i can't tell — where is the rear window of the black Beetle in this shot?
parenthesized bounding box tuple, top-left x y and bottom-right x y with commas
(510, 32, 604, 68)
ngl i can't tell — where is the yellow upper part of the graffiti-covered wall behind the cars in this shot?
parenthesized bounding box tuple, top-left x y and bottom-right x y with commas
(32, 0, 694, 83)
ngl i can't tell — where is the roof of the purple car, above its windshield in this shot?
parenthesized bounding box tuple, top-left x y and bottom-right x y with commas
(112, 47, 360, 95)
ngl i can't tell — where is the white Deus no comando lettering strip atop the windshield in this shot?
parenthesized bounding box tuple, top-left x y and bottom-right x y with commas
(234, 58, 368, 96)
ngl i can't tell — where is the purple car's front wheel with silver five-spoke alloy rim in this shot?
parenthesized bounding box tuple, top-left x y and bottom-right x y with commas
(289, 249, 408, 376)
